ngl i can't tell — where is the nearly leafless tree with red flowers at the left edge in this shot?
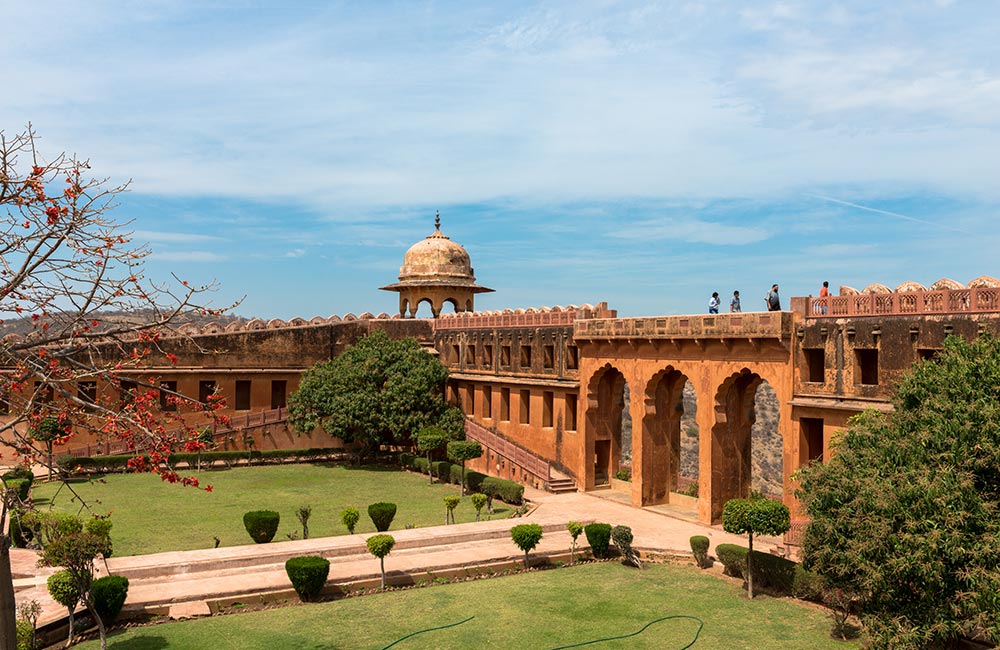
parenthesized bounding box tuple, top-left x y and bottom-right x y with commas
(0, 125, 237, 650)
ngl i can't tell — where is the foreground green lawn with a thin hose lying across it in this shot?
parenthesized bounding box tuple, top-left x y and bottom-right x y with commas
(81, 556, 858, 650)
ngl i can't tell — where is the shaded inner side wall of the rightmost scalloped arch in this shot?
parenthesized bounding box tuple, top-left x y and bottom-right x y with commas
(710, 368, 764, 523)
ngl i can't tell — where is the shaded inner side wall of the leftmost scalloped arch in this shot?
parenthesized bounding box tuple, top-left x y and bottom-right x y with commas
(585, 363, 626, 488)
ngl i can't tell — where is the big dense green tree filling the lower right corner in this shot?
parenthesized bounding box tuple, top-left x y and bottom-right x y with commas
(796, 336, 1000, 648)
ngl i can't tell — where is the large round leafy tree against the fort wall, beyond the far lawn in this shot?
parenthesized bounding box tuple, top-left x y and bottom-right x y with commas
(288, 331, 448, 452)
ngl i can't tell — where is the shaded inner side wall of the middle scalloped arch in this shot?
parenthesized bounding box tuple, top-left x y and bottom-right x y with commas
(640, 366, 688, 506)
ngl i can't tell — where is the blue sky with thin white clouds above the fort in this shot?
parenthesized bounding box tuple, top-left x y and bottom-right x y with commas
(0, 0, 1000, 319)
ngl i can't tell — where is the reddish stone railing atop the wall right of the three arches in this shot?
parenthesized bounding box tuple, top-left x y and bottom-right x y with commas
(792, 287, 1000, 318)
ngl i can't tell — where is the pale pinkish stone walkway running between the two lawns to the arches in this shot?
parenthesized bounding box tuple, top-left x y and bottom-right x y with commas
(12, 488, 764, 624)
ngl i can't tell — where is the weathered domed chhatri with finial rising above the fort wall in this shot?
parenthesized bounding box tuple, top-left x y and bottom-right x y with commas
(381, 213, 493, 318)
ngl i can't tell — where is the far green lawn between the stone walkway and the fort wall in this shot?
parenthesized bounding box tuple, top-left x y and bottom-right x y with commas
(32, 464, 510, 556)
